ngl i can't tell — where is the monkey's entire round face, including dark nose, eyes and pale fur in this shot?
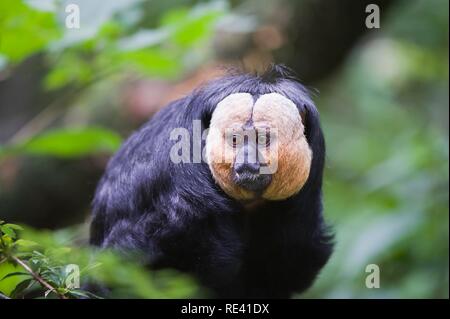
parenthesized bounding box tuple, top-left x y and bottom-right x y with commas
(206, 93, 312, 200)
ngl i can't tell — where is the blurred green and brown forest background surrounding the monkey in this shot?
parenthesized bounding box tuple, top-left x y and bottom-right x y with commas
(0, 0, 449, 298)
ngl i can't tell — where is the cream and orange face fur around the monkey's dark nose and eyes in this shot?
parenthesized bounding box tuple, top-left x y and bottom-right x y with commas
(206, 93, 312, 200)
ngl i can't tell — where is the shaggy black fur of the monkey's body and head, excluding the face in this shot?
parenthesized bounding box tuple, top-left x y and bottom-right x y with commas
(91, 66, 333, 298)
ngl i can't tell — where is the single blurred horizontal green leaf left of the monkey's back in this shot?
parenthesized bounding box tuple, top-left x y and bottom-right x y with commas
(12, 127, 121, 158)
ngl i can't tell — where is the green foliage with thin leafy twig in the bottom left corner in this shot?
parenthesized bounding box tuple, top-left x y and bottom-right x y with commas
(0, 221, 200, 299)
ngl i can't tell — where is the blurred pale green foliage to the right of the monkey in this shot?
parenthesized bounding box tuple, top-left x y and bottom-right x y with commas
(300, 1, 449, 298)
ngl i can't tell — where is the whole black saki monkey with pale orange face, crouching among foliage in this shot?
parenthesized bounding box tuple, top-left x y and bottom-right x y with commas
(91, 65, 333, 298)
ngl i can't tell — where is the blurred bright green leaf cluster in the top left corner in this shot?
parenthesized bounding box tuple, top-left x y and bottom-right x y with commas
(0, 0, 226, 84)
